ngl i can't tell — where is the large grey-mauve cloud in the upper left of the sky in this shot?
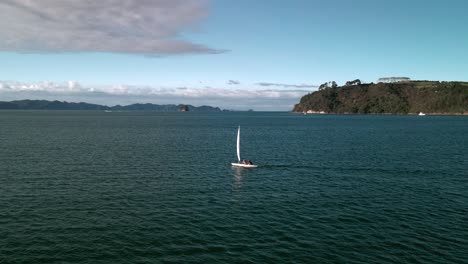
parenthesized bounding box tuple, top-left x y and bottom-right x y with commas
(0, 0, 223, 56)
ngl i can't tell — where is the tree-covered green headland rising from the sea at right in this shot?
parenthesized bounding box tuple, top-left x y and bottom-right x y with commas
(293, 81, 468, 114)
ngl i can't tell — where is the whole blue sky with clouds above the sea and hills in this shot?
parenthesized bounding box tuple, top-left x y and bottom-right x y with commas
(0, 0, 468, 111)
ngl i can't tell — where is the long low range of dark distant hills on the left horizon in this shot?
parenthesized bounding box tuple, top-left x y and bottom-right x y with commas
(0, 100, 222, 112)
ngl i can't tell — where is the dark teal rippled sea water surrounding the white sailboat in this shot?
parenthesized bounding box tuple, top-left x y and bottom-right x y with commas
(0, 111, 468, 263)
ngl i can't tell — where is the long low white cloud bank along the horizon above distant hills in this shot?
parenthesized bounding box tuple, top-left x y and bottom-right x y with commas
(0, 81, 310, 111)
